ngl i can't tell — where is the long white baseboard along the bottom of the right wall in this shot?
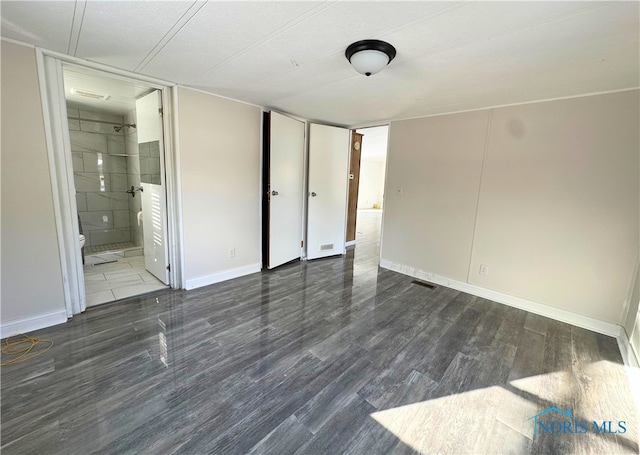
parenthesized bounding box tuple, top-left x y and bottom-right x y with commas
(380, 259, 621, 338)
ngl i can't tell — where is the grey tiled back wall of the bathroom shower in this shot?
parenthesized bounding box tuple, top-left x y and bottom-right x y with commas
(68, 107, 132, 246)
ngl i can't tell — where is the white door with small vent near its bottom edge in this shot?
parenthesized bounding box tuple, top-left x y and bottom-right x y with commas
(307, 124, 349, 259)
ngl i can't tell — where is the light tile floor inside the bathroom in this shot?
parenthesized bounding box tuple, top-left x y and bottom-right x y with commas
(84, 253, 168, 307)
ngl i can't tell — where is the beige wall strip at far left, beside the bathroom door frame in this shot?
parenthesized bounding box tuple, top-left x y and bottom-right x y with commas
(0, 41, 66, 328)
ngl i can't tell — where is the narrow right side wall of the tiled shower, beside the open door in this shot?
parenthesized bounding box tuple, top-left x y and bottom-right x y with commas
(124, 109, 143, 246)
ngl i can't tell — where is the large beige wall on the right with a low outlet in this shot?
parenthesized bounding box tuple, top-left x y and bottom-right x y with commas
(382, 91, 640, 324)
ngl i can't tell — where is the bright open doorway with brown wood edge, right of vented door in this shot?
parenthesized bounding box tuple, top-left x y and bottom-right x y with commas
(346, 125, 389, 257)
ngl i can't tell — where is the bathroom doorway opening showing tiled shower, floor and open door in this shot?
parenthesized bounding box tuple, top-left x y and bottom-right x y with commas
(62, 64, 169, 307)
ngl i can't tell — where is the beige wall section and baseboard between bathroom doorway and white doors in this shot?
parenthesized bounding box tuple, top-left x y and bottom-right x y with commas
(178, 88, 262, 289)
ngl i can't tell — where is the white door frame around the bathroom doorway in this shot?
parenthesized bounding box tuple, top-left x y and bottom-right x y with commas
(35, 47, 184, 318)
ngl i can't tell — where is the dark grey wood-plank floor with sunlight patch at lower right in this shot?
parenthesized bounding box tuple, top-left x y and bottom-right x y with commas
(1, 212, 638, 455)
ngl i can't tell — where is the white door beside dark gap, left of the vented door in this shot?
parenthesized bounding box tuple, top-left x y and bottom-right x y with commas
(267, 112, 304, 269)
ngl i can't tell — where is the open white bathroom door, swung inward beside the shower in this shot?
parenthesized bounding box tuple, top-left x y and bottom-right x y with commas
(136, 90, 169, 284)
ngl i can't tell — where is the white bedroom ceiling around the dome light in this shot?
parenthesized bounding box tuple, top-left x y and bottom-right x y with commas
(0, 0, 640, 126)
